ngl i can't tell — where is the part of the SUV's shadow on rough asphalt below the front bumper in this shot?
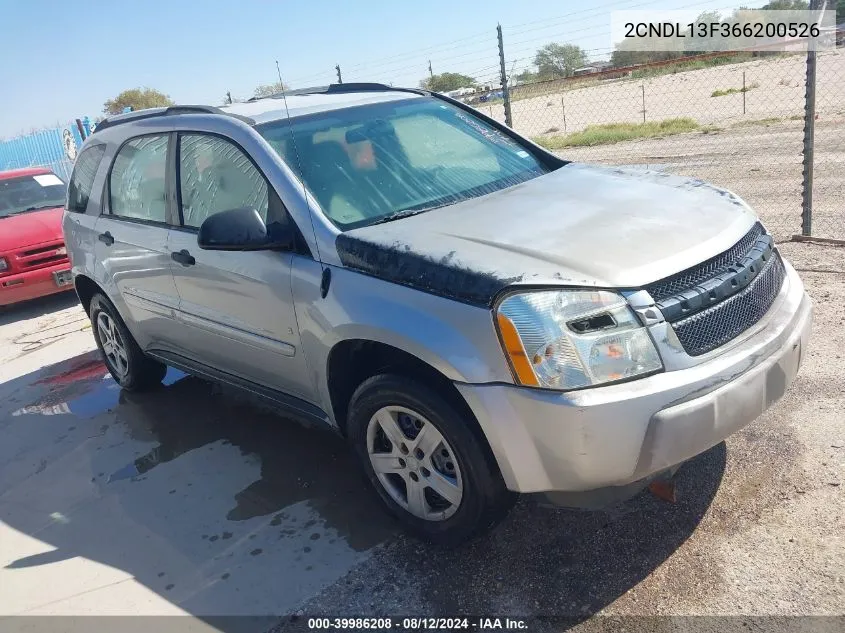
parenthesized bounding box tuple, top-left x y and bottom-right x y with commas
(386, 442, 727, 630)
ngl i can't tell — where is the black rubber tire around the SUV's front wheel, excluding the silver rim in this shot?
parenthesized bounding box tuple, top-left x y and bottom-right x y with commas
(347, 374, 506, 545)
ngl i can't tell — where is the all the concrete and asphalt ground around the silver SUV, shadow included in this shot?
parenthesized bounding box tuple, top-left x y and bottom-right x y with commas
(0, 238, 845, 633)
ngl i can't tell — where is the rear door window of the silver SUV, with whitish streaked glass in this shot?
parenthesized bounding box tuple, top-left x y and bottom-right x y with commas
(109, 134, 168, 223)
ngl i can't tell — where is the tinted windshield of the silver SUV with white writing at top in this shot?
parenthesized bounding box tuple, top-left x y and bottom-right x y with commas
(257, 97, 549, 230)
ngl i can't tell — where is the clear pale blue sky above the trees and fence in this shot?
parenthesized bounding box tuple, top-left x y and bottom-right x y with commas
(0, 0, 763, 138)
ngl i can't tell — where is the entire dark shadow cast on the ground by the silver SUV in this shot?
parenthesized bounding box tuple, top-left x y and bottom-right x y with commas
(0, 352, 726, 630)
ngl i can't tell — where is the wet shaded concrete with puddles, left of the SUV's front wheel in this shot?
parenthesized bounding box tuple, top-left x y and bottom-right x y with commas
(0, 304, 394, 615)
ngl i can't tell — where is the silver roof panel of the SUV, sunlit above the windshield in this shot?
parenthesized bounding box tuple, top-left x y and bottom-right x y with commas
(221, 89, 423, 124)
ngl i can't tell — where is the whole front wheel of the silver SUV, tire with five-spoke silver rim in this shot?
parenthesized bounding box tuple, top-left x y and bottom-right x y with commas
(347, 374, 516, 547)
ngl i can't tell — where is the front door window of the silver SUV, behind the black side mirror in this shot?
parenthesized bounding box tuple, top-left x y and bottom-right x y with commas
(179, 134, 269, 228)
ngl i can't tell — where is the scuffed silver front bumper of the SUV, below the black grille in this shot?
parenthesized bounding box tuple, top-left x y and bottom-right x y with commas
(456, 263, 812, 493)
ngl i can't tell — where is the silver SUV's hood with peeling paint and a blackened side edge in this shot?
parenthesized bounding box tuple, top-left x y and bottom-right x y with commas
(337, 163, 756, 303)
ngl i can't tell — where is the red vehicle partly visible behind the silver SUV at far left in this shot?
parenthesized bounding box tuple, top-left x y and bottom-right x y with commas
(0, 168, 73, 306)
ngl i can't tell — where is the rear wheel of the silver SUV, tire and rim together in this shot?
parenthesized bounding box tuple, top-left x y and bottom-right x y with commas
(90, 293, 167, 391)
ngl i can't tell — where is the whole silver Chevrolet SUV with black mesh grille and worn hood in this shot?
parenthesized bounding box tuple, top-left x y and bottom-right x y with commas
(64, 84, 812, 543)
